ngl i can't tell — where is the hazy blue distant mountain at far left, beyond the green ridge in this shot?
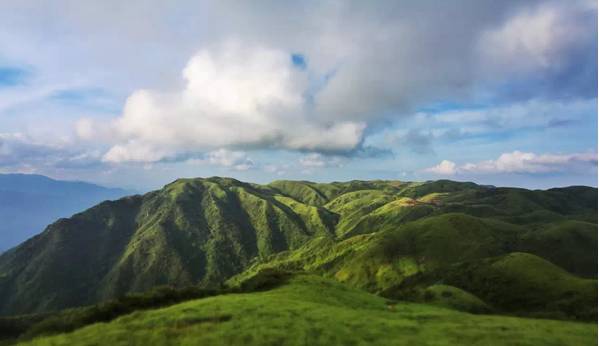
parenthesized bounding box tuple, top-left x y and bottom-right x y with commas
(0, 174, 127, 252)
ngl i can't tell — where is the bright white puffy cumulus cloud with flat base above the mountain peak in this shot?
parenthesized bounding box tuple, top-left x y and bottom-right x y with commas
(97, 42, 365, 162)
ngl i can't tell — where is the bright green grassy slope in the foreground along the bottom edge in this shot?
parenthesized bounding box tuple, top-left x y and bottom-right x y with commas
(25, 275, 597, 345)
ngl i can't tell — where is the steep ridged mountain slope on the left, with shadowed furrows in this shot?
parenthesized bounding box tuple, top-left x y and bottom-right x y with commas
(0, 178, 336, 313)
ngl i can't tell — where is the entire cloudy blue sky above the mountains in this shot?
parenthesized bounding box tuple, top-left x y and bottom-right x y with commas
(0, 0, 598, 191)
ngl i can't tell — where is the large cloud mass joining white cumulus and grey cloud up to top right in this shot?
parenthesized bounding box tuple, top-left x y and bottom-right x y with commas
(59, 1, 596, 166)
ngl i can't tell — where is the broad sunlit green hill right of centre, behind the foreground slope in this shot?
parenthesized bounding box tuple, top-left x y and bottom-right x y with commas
(234, 214, 520, 292)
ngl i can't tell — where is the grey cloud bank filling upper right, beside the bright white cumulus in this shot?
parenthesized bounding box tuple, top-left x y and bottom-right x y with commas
(217, 1, 597, 117)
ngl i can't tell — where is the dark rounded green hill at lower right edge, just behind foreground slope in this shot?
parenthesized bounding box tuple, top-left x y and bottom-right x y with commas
(442, 253, 597, 320)
